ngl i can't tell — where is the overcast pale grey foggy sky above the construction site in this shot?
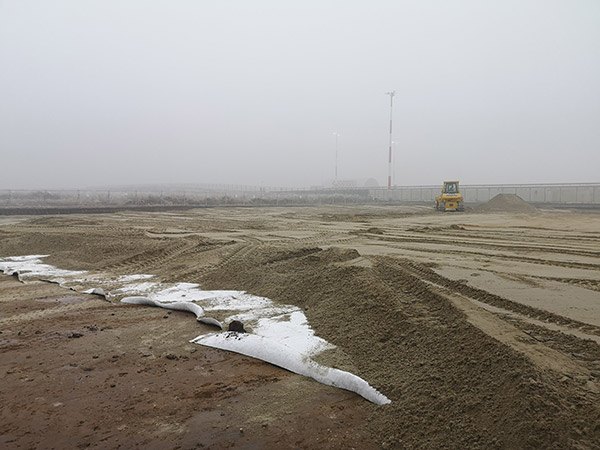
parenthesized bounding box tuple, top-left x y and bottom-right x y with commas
(0, 0, 600, 189)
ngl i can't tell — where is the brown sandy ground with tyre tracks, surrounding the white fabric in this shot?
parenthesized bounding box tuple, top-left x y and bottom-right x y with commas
(0, 206, 600, 448)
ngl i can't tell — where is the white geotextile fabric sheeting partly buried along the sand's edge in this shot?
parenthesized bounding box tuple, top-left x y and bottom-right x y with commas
(0, 255, 390, 405)
